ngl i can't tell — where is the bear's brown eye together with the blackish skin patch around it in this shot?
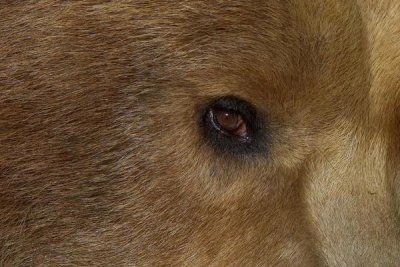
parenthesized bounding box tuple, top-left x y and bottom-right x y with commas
(200, 96, 266, 154)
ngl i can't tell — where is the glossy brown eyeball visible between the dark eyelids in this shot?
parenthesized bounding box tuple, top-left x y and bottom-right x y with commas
(211, 109, 247, 138)
